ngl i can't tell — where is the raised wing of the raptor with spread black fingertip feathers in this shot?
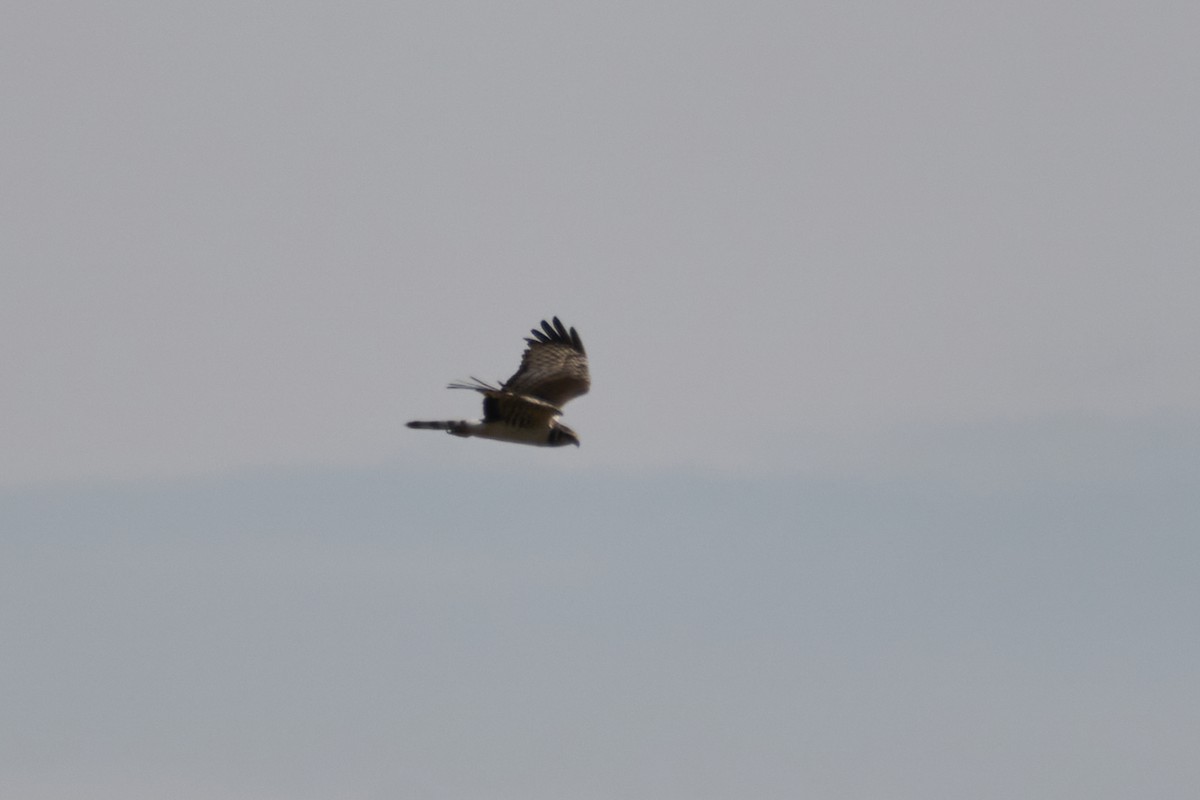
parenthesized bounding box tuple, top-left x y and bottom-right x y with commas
(500, 317, 592, 408)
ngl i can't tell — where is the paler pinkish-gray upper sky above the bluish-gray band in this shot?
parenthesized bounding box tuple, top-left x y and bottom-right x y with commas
(0, 2, 1200, 485)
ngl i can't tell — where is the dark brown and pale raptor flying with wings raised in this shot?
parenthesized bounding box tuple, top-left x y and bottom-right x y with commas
(408, 317, 592, 447)
